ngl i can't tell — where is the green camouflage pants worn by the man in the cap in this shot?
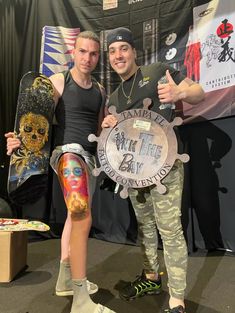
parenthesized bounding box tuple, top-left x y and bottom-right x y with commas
(129, 161, 188, 299)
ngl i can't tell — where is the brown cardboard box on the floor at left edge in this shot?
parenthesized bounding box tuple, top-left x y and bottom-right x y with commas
(0, 231, 28, 283)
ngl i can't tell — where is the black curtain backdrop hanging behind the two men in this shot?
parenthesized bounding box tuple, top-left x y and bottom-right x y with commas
(0, 0, 235, 251)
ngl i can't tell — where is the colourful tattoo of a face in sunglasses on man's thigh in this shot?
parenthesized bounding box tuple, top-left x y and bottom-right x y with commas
(58, 153, 89, 217)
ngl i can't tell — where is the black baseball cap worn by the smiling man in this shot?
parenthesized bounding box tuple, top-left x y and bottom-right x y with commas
(107, 27, 135, 47)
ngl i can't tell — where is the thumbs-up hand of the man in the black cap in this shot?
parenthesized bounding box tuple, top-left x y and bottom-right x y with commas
(157, 70, 185, 103)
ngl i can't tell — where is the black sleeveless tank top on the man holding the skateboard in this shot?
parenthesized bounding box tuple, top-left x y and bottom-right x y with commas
(54, 71, 102, 154)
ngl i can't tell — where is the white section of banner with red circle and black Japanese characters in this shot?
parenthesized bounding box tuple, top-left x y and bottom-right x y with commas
(194, 0, 235, 92)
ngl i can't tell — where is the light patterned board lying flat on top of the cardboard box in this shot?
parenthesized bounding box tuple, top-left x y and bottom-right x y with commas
(0, 218, 50, 231)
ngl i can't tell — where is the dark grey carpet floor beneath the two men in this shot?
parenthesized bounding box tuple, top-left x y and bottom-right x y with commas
(0, 238, 235, 313)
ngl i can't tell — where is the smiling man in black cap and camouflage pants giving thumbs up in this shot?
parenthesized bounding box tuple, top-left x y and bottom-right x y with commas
(102, 27, 204, 313)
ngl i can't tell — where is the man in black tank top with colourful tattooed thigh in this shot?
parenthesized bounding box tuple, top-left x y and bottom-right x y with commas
(5, 31, 114, 313)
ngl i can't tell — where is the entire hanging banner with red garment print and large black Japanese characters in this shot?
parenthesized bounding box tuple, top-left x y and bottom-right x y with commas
(183, 0, 235, 120)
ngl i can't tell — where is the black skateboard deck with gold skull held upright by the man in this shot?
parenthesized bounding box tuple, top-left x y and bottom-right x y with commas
(8, 72, 54, 204)
